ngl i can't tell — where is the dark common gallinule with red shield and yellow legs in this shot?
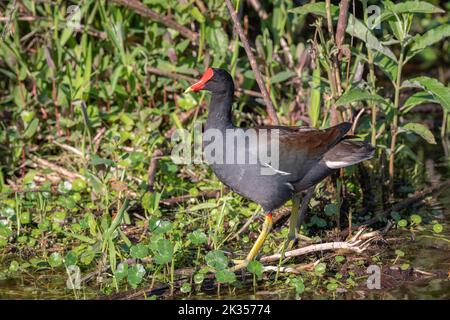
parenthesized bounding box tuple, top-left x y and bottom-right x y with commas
(186, 68, 375, 270)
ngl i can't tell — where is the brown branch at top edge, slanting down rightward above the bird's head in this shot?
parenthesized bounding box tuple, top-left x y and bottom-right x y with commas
(113, 0, 198, 42)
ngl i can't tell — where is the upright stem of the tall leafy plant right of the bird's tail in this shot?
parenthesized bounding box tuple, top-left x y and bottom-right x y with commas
(389, 45, 405, 191)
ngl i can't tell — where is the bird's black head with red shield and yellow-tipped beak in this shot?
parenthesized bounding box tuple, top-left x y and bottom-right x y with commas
(186, 68, 234, 93)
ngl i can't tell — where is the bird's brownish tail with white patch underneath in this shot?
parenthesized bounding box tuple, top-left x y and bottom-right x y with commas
(323, 140, 375, 169)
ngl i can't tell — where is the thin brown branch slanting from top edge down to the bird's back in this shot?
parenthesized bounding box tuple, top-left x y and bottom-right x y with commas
(225, 0, 279, 125)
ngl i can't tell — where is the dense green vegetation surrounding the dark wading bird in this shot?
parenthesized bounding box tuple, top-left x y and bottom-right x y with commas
(0, 0, 450, 299)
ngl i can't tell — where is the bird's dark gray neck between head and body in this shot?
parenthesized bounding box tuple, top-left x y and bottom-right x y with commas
(205, 88, 234, 130)
